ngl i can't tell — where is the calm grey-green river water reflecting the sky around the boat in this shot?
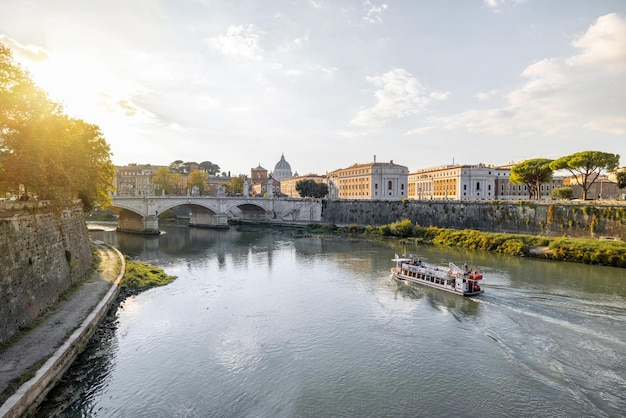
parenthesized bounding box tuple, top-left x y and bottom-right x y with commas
(37, 226, 626, 417)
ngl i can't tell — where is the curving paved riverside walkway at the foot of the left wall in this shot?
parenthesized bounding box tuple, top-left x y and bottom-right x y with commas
(0, 242, 125, 418)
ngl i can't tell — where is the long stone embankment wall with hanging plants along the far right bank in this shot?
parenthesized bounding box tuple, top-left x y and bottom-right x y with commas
(322, 200, 626, 241)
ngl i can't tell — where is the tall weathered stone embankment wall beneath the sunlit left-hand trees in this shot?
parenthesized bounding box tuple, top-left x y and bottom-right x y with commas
(0, 202, 92, 343)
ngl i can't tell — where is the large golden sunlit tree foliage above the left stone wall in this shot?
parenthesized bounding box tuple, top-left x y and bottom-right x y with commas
(0, 44, 115, 210)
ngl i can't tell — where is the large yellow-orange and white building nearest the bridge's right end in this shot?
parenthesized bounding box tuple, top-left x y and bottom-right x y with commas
(326, 157, 409, 200)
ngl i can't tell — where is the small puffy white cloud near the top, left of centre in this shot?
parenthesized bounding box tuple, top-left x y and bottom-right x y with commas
(206, 25, 263, 60)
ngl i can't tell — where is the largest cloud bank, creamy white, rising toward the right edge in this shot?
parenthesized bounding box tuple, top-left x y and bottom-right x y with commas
(426, 14, 626, 137)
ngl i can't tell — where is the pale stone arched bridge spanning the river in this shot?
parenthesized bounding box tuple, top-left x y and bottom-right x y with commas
(111, 196, 322, 234)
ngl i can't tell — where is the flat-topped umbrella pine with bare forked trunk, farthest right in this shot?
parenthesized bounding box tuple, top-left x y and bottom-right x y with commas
(550, 151, 619, 200)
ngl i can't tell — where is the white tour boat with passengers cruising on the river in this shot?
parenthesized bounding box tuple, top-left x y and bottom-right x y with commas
(391, 254, 484, 296)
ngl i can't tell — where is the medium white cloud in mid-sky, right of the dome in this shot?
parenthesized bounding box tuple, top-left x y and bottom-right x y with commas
(350, 69, 448, 127)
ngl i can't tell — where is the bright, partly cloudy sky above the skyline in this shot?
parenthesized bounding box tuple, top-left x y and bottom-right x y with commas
(0, 0, 626, 175)
